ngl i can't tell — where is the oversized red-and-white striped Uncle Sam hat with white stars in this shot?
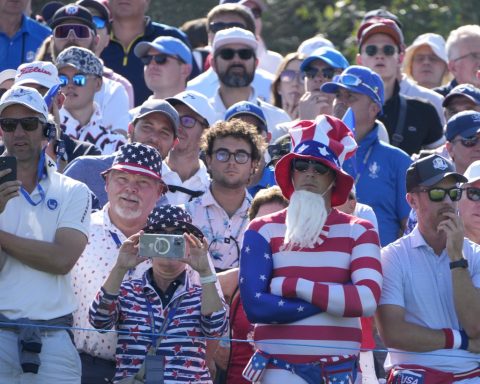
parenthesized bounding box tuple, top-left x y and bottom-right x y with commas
(275, 115, 357, 207)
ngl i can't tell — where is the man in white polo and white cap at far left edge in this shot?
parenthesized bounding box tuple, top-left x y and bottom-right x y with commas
(0, 86, 90, 384)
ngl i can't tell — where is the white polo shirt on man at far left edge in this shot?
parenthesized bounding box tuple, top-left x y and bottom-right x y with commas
(0, 156, 91, 320)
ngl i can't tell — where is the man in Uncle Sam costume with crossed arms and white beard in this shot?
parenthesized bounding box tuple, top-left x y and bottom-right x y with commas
(240, 115, 382, 384)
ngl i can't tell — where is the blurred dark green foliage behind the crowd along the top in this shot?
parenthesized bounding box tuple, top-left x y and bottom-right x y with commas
(32, 0, 480, 59)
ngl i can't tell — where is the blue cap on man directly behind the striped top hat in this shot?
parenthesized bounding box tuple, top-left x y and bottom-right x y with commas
(320, 65, 385, 110)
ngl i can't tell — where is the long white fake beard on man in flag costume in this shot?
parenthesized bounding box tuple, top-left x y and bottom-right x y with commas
(284, 190, 328, 250)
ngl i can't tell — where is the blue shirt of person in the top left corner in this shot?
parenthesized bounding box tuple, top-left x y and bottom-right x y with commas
(0, 15, 52, 71)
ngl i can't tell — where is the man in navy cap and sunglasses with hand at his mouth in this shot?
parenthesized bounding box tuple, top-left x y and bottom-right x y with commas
(376, 155, 480, 383)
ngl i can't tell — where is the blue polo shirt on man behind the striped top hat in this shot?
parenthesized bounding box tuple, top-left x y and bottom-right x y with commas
(343, 126, 412, 247)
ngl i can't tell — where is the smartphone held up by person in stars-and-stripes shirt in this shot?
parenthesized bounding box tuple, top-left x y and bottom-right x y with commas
(138, 233, 185, 259)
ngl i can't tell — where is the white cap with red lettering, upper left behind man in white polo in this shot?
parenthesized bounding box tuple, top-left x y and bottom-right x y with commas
(15, 61, 60, 89)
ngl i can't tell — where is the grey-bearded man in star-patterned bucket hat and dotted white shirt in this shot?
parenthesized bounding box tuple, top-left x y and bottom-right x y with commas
(72, 143, 165, 384)
